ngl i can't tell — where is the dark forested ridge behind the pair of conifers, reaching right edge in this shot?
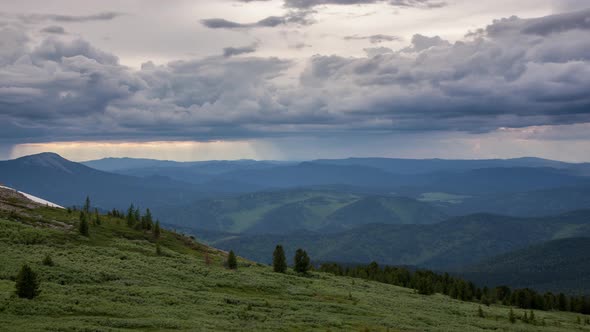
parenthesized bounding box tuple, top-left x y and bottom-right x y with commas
(207, 210, 590, 271)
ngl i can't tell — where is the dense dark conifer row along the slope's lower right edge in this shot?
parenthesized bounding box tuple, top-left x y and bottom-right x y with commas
(319, 262, 590, 314)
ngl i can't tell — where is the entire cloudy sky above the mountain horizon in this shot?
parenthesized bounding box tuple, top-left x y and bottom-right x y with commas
(0, 0, 590, 162)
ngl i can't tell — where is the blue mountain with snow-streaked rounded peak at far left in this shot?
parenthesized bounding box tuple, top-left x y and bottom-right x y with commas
(0, 153, 203, 208)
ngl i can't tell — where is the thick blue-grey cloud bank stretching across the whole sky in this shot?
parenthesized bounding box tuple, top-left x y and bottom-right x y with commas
(0, 8, 590, 141)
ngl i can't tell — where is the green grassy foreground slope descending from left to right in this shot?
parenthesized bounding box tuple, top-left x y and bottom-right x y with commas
(0, 208, 590, 331)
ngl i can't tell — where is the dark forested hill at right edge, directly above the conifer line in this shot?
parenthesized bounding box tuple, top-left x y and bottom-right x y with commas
(458, 237, 590, 294)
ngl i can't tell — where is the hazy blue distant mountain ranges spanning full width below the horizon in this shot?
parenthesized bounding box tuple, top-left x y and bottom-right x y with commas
(0, 153, 590, 224)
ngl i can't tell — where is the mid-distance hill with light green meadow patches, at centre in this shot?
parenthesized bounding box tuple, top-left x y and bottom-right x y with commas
(155, 189, 445, 234)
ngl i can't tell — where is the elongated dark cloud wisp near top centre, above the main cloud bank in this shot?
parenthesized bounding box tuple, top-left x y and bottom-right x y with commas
(201, 11, 314, 29)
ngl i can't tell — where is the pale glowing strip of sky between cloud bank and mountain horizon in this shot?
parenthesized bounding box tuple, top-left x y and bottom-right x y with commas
(3, 139, 587, 163)
